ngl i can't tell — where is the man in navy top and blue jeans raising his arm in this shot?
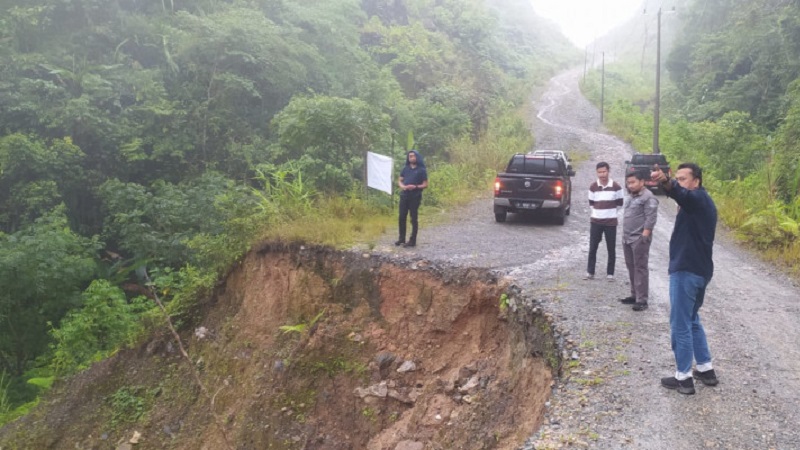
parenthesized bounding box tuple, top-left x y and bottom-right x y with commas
(650, 163, 717, 394)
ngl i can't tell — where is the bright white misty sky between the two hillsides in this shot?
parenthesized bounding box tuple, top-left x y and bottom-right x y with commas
(530, 0, 643, 47)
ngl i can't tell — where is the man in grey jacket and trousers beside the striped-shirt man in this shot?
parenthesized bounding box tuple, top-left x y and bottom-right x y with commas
(620, 170, 658, 311)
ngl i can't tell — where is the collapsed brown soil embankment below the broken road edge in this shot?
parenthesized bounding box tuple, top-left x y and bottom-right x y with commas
(0, 244, 559, 450)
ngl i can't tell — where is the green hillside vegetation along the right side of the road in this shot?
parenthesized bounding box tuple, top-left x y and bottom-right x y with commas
(584, 0, 800, 274)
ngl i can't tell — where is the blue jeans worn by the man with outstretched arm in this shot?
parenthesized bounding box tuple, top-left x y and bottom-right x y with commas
(669, 272, 711, 375)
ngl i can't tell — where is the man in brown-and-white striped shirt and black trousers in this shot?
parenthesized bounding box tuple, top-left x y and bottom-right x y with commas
(584, 162, 624, 281)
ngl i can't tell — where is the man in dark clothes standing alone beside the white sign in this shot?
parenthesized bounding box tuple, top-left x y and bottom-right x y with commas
(394, 150, 428, 247)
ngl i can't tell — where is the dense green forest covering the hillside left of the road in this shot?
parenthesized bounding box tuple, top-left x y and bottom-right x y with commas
(0, 0, 577, 418)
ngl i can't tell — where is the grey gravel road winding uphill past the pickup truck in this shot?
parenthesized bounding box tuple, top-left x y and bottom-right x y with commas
(379, 71, 800, 449)
